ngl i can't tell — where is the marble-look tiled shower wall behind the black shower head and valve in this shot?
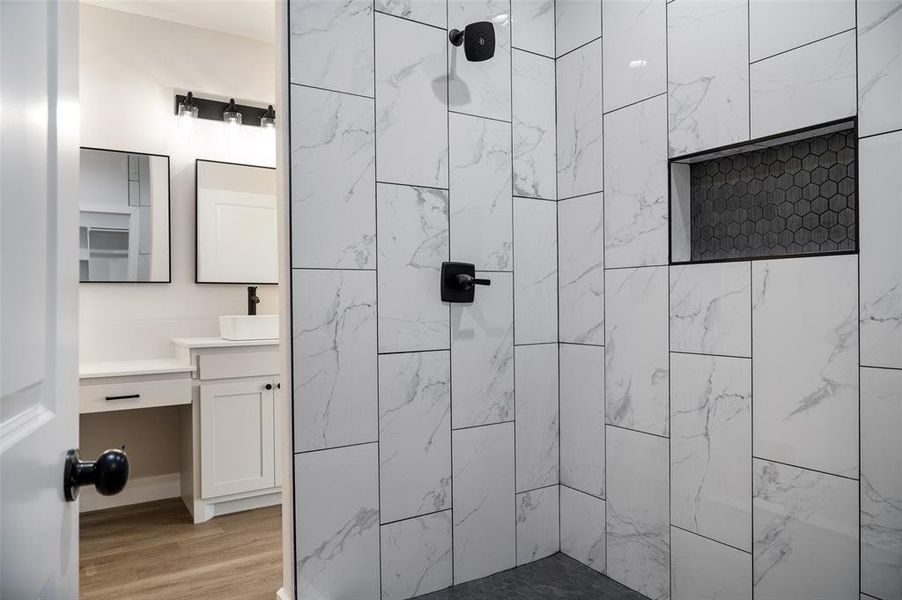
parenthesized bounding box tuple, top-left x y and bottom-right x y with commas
(289, 0, 556, 600)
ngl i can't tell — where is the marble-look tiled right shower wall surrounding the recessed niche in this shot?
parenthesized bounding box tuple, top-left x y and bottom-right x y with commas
(556, 0, 902, 600)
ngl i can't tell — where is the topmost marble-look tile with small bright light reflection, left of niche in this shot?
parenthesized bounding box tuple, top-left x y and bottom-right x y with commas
(602, 0, 667, 111)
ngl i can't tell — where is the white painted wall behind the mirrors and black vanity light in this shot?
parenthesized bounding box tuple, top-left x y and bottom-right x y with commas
(79, 4, 278, 361)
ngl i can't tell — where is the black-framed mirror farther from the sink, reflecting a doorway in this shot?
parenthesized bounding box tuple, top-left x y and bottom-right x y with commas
(78, 148, 170, 283)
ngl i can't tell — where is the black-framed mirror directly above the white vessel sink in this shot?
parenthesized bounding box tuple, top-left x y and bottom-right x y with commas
(195, 160, 278, 285)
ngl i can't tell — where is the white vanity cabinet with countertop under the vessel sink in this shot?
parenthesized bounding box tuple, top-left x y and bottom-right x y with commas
(173, 338, 282, 523)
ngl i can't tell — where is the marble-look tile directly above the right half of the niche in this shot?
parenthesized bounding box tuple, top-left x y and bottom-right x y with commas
(751, 33, 857, 138)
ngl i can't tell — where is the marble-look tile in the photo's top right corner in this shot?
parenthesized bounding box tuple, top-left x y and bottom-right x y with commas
(858, 0, 902, 135)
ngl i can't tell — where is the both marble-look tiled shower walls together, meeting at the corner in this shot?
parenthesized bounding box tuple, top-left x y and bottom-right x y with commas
(289, 0, 902, 600)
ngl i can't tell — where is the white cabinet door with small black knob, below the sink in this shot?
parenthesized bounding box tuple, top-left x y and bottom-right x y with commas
(200, 378, 275, 498)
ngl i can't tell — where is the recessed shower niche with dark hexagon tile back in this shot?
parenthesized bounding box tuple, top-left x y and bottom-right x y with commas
(670, 120, 858, 264)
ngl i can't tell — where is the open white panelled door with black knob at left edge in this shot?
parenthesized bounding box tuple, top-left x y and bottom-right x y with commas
(0, 0, 79, 600)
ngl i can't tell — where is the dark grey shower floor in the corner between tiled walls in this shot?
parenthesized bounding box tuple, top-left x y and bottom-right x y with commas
(417, 553, 646, 600)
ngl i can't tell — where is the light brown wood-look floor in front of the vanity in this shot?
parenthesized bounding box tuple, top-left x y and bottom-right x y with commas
(80, 499, 282, 600)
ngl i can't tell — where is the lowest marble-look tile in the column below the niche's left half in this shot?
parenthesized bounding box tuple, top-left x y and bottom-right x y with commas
(670, 525, 752, 600)
